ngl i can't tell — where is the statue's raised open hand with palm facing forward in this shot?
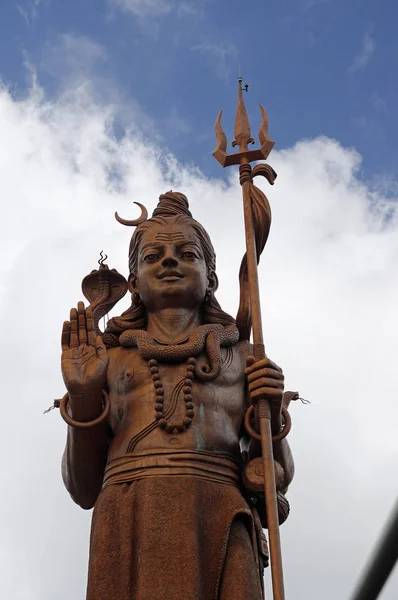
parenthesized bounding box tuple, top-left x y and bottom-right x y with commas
(61, 302, 109, 396)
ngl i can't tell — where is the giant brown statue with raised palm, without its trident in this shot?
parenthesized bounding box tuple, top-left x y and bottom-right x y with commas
(60, 82, 297, 600)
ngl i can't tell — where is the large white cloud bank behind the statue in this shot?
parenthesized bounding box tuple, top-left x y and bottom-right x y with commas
(0, 76, 398, 600)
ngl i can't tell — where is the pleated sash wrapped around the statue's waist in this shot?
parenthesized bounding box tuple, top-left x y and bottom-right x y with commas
(102, 450, 242, 489)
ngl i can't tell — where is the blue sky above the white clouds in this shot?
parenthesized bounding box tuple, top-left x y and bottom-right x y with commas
(0, 0, 398, 180)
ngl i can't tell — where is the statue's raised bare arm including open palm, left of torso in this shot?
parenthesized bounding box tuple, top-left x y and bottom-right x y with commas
(61, 302, 109, 508)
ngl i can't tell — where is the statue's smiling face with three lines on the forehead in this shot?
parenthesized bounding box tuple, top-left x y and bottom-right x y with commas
(131, 223, 209, 310)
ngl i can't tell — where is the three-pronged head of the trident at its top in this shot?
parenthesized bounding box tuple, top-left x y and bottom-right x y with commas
(213, 77, 275, 167)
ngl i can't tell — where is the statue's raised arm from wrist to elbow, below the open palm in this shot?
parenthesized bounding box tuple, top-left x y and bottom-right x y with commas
(62, 393, 109, 509)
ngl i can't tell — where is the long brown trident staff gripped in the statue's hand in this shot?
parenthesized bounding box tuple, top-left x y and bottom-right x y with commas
(213, 78, 287, 600)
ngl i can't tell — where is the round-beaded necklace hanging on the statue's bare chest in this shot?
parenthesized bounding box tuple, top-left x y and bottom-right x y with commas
(148, 357, 196, 433)
